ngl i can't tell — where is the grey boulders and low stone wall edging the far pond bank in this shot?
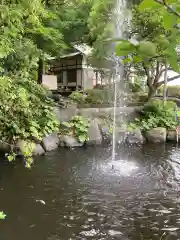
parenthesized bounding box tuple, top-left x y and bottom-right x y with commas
(0, 107, 180, 158)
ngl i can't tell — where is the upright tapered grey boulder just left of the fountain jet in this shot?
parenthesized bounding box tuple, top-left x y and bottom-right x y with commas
(87, 119, 102, 145)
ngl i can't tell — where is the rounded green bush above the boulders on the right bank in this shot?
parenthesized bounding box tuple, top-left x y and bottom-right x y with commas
(129, 100, 177, 131)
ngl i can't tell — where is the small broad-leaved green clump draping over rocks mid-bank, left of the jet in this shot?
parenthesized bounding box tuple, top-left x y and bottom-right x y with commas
(60, 116, 89, 143)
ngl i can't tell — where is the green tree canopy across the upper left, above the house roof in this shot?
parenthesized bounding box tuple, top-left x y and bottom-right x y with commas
(0, 0, 113, 77)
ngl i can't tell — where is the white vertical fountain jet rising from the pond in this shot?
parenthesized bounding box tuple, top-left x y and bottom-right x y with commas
(112, 0, 127, 161)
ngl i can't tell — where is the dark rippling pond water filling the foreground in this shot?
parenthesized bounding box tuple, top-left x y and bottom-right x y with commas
(0, 145, 180, 240)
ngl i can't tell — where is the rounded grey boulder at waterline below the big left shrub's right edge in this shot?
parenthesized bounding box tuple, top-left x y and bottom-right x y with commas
(42, 133, 59, 152)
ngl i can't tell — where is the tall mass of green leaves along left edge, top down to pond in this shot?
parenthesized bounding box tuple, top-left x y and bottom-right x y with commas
(0, 0, 62, 167)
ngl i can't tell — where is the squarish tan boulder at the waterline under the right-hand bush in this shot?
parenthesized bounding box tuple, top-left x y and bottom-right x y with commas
(146, 127, 166, 143)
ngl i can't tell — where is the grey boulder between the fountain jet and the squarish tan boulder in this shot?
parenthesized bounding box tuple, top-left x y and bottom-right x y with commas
(125, 128, 144, 144)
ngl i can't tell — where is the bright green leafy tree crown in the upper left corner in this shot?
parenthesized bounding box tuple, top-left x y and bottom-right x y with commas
(0, 0, 64, 82)
